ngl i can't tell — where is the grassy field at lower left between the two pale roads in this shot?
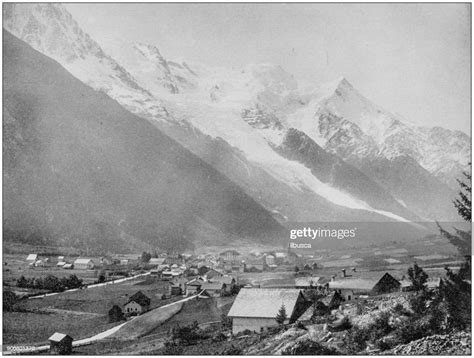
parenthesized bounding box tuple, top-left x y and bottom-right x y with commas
(3, 279, 181, 344)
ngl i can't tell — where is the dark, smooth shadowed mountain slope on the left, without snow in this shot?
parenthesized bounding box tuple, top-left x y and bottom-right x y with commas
(3, 31, 282, 251)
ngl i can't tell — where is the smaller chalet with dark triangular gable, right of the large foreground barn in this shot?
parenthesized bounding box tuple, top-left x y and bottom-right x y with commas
(329, 272, 402, 301)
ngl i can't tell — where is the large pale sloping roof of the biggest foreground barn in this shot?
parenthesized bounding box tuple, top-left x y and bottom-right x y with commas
(228, 288, 301, 318)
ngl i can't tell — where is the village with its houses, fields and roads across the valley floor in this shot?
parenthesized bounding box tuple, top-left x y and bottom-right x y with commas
(3, 241, 470, 354)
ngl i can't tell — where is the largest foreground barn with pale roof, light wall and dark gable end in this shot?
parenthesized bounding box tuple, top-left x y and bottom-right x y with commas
(228, 288, 308, 334)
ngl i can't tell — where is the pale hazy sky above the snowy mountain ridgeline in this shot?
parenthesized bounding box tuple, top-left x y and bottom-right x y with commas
(66, 3, 471, 133)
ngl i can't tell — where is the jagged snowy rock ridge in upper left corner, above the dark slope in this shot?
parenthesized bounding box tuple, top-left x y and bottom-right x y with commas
(3, 3, 167, 119)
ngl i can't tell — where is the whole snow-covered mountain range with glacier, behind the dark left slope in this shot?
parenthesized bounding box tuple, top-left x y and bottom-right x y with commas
(4, 4, 470, 227)
